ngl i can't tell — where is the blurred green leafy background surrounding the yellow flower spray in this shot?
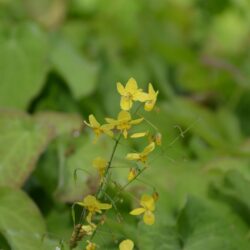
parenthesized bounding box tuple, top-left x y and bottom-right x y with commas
(0, 0, 250, 250)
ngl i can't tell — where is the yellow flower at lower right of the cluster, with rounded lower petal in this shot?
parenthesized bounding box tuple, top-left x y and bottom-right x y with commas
(130, 194, 155, 225)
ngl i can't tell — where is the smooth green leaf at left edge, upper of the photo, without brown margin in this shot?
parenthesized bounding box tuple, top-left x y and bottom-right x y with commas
(0, 25, 48, 109)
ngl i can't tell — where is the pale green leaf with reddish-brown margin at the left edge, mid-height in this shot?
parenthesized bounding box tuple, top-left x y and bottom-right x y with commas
(0, 111, 53, 187)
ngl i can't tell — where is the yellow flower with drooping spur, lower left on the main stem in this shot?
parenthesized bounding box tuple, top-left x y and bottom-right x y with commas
(77, 195, 112, 224)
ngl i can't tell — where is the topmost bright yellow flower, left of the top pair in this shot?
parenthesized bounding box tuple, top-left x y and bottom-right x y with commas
(117, 78, 148, 110)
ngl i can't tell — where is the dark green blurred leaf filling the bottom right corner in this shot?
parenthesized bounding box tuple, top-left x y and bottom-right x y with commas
(177, 198, 250, 250)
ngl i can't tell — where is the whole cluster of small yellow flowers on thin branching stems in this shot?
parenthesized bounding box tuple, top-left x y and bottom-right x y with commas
(74, 78, 161, 250)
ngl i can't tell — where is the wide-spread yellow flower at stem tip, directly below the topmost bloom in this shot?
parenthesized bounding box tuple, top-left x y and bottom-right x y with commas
(105, 110, 143, 139)
